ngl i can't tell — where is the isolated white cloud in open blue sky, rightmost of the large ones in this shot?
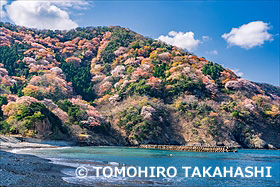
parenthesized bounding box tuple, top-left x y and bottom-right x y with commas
(222, 21, 273, 49)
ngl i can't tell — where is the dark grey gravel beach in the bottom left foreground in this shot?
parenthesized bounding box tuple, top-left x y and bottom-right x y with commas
(0, 150, 85, 187)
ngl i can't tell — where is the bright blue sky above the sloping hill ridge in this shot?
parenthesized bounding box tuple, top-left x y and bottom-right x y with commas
(1, 0, 280, 86)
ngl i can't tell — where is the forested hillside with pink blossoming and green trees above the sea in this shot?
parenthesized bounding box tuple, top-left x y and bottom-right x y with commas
(0, 23, 280, 148)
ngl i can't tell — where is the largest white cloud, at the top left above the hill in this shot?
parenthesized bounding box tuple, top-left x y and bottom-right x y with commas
(5, 0, 89, 30)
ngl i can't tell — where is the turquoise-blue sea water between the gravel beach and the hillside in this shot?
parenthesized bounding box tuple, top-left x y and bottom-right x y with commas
(16, 147, 280, 187)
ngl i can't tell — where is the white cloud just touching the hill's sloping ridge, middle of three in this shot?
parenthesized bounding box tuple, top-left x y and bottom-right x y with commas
(158, 31, 200, 51)
